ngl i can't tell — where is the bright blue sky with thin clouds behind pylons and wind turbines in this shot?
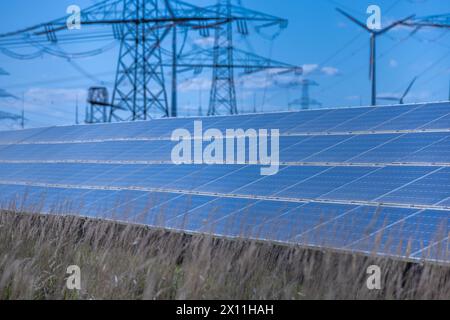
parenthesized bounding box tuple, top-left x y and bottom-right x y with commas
(0, 0, 450, 129)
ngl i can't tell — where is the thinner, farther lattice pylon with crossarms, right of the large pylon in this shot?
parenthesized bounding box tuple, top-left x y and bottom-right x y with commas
(172, 0, 303, 115)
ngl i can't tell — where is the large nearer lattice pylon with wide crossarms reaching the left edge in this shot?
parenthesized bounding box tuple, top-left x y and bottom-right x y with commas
(0, 0, 287, 121)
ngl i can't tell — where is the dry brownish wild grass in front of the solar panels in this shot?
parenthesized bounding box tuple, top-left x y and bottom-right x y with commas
(0, 212, 450, 299)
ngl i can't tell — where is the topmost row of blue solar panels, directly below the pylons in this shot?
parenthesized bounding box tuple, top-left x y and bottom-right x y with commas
(0, 103, 450, 144)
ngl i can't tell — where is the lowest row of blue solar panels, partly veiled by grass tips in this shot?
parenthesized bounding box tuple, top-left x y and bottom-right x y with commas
(1, 186, 449, 260)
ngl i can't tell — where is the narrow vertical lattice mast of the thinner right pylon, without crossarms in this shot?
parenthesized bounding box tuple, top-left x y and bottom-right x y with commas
(208, 0, 238, 116)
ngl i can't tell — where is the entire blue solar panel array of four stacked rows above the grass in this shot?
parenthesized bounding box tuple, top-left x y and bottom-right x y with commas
(0, 103, 450, 262)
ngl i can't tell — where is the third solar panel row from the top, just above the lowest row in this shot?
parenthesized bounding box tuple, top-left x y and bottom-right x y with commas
(0, 164, 450, 209)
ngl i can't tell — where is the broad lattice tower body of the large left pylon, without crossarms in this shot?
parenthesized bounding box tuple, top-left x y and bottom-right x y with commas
(110, 0, 169, 121)
